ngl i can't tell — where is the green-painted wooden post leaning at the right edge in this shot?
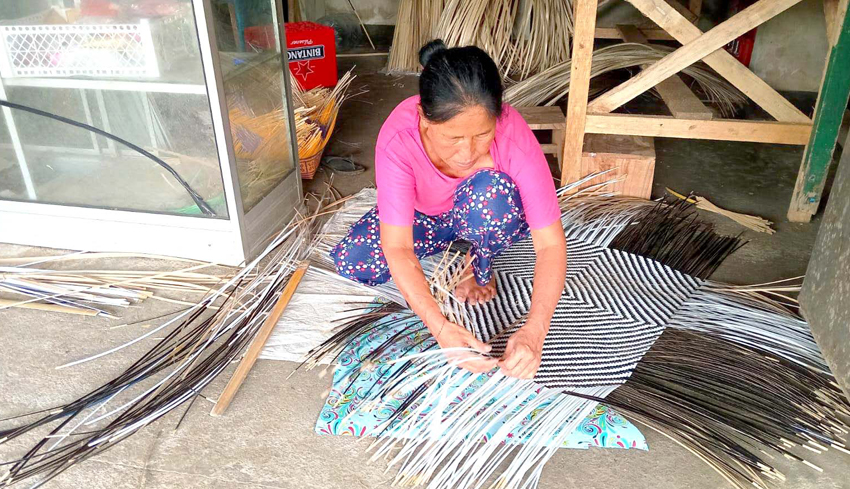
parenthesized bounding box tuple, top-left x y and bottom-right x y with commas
(788, 1, 850, 222)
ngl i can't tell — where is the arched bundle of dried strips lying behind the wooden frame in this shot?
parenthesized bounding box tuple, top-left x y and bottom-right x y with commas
(504, 43, 746, 116)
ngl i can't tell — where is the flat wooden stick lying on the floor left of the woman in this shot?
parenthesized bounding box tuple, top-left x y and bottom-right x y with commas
(210, 261, 310, 416)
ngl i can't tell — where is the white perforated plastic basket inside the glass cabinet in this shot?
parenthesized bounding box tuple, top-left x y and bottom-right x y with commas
(0, 21, 159, 78)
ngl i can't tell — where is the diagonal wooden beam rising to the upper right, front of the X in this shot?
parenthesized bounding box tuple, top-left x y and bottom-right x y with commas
(588, 0, 801, 114)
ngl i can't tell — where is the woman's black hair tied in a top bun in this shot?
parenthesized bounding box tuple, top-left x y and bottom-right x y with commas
(419, 39, 502, 123)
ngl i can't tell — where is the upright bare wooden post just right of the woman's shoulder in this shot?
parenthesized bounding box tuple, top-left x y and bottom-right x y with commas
(561, 0, 597, 185)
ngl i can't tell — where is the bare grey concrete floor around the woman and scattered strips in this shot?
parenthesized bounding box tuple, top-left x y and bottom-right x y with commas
(0, 58, 850, 489)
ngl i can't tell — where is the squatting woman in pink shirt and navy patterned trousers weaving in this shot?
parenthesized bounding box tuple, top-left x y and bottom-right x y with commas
(332, 40, 567, 378)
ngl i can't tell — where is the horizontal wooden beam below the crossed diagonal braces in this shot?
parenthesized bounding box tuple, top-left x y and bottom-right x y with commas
(585, 114, 812, 145)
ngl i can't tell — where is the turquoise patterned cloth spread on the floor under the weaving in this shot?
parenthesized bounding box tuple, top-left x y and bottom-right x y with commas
(316, 308, 649, 450)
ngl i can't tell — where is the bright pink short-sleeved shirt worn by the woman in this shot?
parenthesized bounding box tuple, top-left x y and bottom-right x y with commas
(375, 95, 561, 229)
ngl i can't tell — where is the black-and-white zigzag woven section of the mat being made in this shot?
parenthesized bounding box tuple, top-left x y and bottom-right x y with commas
(454, 238, 702, 389)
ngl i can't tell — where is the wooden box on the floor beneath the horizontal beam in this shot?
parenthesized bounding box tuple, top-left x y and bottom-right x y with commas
(579, 134, 655, 199)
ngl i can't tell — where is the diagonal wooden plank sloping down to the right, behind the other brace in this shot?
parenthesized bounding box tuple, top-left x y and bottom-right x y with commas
(629, 0, 811, 122)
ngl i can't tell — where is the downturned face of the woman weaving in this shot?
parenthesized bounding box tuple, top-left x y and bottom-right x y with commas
(419, 106, 496, 173)
